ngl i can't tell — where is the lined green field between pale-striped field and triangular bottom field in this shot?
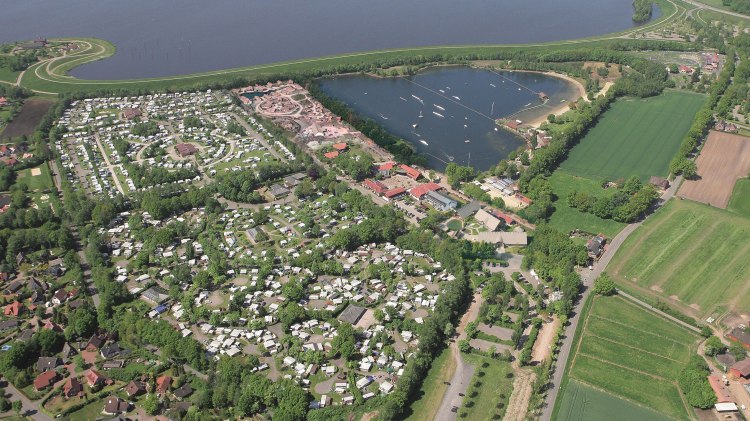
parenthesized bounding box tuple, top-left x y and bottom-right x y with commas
(560, 296, 697, 419)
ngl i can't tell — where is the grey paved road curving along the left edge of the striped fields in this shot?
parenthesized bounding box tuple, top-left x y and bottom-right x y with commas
(540, 176, 682, 421)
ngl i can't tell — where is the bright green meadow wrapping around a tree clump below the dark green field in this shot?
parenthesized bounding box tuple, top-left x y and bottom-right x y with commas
(549, 170, 626, 238)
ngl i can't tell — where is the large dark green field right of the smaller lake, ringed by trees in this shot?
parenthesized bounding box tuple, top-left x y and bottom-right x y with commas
(560, 91, 705, 181)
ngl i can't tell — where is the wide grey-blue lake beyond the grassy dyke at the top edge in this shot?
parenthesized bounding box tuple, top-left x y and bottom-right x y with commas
(0, 0, 659, 79)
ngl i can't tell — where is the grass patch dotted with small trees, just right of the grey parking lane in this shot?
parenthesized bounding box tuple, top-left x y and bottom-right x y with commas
(458, 354, 513, 421)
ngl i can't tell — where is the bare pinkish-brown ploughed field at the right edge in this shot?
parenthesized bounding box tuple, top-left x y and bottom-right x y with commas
(677, 131, 750, 209)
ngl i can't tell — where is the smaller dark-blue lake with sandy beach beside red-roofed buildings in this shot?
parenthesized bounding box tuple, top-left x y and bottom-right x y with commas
(318, 67, 579, 170)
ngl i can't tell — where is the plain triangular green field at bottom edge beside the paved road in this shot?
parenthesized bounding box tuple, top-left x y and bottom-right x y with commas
(557, 380, 670, 421)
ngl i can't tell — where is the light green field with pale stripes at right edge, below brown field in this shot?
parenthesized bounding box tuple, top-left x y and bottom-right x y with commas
(609, 199, 750, 318)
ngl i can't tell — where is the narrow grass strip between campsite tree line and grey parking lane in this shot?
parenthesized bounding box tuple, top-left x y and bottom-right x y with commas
(407, 348, 456, 421)
